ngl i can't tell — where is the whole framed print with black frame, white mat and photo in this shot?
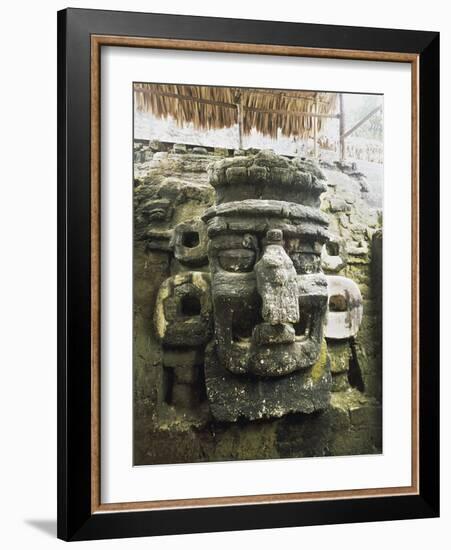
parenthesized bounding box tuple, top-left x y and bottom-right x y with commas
(58, 9, 439, 540)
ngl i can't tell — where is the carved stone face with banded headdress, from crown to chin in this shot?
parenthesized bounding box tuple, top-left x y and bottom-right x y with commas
(203, 152, 328, 377)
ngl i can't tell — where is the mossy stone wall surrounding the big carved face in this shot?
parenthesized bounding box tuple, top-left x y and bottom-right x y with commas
(133, 142, 382, 465)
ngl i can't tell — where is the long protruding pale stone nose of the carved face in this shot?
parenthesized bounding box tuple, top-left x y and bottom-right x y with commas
(254, 229, 299, 325)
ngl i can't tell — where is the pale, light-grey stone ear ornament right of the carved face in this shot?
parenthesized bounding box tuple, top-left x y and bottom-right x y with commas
(326, 275, 363, 340)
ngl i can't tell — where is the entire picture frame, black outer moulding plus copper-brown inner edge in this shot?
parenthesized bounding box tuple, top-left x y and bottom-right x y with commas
(57, 8, 440, 540)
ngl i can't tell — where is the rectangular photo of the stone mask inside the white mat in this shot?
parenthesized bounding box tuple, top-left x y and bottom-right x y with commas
(133, 81, 384, 466)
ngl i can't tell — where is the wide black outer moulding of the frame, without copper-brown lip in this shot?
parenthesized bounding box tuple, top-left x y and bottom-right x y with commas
(58, 9, 439, 540)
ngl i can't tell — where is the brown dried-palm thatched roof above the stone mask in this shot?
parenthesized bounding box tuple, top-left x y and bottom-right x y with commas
(134, 83, 336, 138)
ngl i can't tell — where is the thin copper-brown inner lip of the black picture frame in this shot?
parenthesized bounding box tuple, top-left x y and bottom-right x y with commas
(91, 34, 420, 514)
